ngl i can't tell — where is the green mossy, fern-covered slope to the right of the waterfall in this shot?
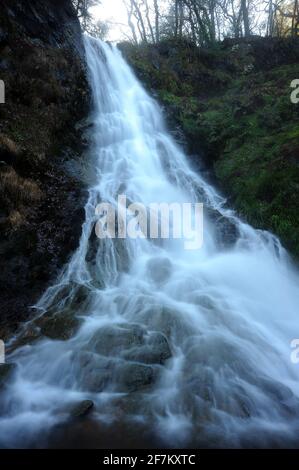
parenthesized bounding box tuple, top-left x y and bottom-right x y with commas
(122, 38, 299, 259)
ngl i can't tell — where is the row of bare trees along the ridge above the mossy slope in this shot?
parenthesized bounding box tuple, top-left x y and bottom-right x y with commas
(120, 0, 299, 45)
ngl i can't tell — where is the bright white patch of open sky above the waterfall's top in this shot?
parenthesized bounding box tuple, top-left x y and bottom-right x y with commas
(90, 0, 129, 42)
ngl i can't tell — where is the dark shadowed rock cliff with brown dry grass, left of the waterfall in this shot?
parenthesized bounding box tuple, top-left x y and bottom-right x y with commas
(0, 0, 89, 338)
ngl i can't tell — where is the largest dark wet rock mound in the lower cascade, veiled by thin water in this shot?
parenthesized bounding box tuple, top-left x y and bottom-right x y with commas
(72, 325, 171, 393)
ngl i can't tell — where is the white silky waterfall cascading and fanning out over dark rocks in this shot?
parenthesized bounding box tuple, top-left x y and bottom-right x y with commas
(0, 38, 299, 447)
